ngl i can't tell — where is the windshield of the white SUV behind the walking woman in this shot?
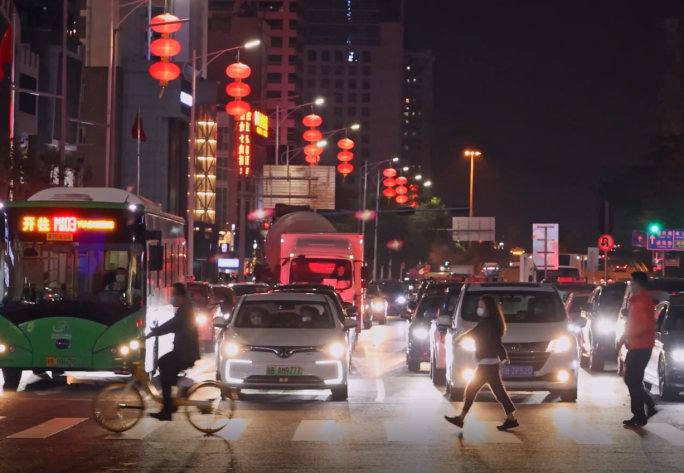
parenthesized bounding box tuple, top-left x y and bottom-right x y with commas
(461, 290, 567, 323)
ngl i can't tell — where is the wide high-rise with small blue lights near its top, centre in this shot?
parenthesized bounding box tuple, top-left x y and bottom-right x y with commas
(300, 0, 404, 170)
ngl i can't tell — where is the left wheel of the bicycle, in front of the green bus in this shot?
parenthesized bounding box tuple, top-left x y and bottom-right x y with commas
(93, 383, 145, 432)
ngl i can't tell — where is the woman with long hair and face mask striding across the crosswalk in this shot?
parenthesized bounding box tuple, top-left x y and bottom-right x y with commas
(444, 295, 519, 430)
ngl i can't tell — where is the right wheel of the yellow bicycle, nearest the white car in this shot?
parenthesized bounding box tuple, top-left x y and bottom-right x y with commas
(185, 381, 235, 434)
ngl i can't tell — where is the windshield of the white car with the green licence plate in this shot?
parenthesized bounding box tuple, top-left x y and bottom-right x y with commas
(235, 300, 335, 329)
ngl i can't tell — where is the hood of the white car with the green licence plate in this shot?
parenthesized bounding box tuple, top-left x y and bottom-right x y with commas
(228, 328, 344, 347)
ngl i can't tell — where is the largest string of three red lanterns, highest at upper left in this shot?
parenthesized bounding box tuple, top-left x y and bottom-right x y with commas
(150, 13, 181, 98)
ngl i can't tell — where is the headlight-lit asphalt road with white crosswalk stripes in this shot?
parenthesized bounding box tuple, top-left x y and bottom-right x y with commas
(0, 319, 684, 473)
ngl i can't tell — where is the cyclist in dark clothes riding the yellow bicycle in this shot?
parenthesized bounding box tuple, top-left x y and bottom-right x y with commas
(147, 283, 200, 420)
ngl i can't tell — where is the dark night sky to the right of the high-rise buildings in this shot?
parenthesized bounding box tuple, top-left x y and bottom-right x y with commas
(405, 5, 662, 252)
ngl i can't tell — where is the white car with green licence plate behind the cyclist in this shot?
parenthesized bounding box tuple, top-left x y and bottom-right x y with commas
(214, 292, 357, 401)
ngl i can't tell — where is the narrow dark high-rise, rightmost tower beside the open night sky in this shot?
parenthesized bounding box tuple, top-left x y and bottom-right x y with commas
(401, 51, 435, 174)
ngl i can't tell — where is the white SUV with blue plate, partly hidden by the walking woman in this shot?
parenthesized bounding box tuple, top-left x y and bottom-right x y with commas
(445, 283, 579, 402)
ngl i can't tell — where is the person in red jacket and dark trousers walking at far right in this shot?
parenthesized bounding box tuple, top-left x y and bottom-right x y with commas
(618, 272, 658, 427)
